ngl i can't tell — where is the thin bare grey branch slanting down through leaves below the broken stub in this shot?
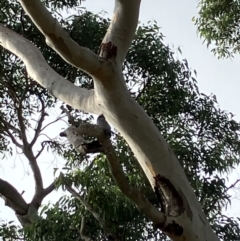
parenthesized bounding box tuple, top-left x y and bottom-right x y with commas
(60, 173, 117, 240)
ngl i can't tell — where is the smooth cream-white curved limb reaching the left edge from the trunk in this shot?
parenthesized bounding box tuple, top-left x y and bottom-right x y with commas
(0, 24, 97, 113)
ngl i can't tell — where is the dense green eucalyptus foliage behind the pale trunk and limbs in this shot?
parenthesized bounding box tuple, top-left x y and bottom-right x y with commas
(0, 0, 240, 241)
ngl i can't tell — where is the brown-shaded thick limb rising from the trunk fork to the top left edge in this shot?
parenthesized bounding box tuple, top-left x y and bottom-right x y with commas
(18, 0, 102, 75)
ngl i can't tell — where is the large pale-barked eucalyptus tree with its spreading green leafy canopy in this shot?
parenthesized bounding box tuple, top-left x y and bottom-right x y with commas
(0, 0, 239, 241)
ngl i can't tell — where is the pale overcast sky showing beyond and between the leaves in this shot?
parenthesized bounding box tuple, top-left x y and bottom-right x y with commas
(0, 0, 240, 230)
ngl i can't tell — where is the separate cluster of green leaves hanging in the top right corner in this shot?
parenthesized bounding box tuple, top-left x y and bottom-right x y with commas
(193, 0, 240, 57)
